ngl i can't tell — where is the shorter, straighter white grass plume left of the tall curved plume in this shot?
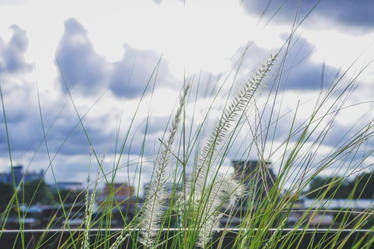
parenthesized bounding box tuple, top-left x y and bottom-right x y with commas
(141, 85, 190, 248)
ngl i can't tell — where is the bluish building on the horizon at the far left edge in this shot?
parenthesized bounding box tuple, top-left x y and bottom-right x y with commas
(0, 165, 44, 185)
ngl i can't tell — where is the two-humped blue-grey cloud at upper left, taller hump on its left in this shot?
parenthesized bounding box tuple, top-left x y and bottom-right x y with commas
(56, 19, 176, 98)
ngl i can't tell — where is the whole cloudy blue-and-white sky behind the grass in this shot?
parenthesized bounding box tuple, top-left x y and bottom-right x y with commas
(0, 0, 374, 192)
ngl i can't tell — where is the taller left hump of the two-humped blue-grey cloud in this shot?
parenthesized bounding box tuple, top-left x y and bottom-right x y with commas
(56, 19, 109, 95)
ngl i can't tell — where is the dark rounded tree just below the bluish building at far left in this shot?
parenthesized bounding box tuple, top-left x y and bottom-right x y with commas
(19, 178, 54, 205)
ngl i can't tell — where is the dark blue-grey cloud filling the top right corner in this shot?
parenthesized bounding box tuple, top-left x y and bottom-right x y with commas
(244, 0, 374, 29)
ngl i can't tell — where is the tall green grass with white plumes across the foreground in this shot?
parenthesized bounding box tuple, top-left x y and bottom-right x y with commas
(0, 13, 374, 249)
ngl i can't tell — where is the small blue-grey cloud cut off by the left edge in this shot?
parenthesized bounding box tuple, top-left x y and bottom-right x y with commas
(0, 25, 32, 75)
